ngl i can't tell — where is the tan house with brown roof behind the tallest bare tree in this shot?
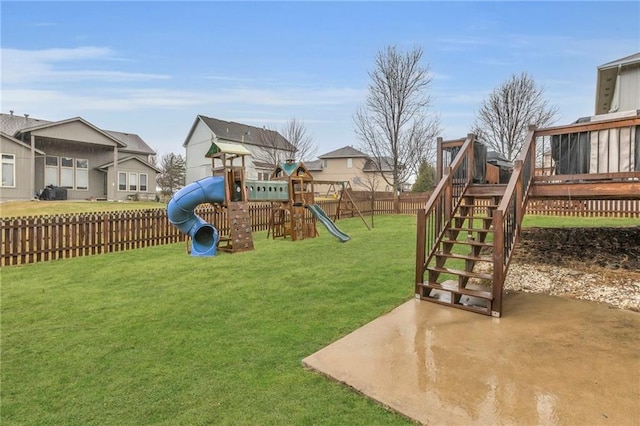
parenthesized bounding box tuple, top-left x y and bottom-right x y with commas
(309, 146, 392, 193)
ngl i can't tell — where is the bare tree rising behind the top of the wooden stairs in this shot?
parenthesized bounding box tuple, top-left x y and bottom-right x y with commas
(473, 72, 558, 161)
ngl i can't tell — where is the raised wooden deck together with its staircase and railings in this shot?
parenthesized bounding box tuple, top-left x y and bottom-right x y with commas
(415, 112, 640, 317)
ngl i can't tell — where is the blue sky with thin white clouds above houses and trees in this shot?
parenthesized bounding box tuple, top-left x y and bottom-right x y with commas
(0, 0, 640, 160)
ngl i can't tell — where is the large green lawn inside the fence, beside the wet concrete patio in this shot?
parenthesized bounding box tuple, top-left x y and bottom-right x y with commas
(0, 216, 415, 425)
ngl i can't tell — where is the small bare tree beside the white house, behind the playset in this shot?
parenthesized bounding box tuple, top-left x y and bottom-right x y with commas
(255, 117, 316, 167)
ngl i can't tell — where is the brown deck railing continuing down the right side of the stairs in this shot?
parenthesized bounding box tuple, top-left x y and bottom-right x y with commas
(492, 112, 640, 313)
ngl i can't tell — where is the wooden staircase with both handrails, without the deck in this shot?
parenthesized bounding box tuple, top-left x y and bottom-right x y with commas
(415, 132, 535, 317)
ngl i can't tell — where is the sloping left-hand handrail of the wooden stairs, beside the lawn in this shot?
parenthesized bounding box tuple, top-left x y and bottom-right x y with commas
(415, 133, 475, 297)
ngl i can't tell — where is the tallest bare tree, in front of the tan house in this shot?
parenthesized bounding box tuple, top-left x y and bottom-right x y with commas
(354, 46, 440, 203)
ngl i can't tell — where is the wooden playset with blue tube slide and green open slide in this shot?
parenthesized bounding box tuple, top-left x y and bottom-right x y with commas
(167, 142, 358, 257)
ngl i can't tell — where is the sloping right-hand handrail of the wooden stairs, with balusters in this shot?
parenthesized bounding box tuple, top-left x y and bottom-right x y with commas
(491, 125, 536, 317)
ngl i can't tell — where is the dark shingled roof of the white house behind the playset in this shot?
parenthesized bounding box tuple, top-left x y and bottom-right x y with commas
(182, 115, 296, 151)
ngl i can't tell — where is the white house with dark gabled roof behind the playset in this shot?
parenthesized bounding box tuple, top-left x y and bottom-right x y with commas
(182, 115, 296, 184)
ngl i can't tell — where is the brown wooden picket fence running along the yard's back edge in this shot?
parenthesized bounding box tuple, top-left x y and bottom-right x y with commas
(0, 195, 640, 266)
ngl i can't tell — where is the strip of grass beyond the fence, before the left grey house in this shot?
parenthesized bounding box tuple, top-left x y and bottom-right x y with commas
(0, 200, 167, 217)
